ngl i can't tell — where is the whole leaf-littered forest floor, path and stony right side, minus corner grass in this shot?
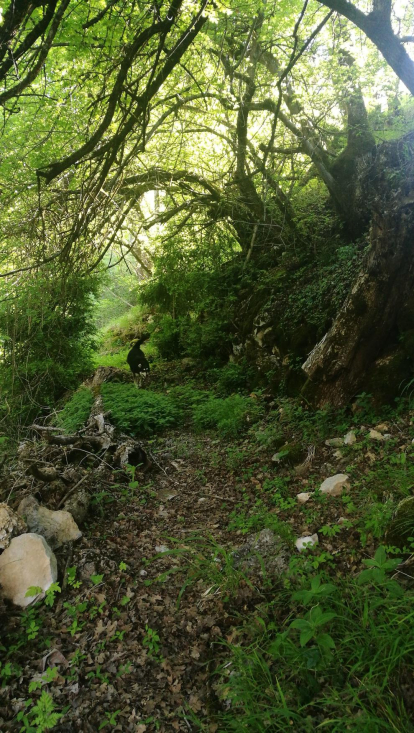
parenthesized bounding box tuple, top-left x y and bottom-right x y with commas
(0, 362, 414, 733)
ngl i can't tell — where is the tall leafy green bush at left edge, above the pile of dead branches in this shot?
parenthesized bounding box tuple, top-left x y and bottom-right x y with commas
(0, 270, 98, 428)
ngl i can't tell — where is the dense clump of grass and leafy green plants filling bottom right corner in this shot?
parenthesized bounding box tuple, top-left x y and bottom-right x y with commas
(212, 548, 414, 733)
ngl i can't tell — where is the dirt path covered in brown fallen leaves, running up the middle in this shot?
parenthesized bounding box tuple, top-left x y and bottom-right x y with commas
(0, 435, 254, 733)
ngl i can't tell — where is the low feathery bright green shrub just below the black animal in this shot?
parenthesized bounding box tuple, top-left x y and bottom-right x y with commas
(101, 383, 182, 438)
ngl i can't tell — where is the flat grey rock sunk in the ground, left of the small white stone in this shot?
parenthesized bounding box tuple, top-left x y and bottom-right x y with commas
(233, 529, 290, 577)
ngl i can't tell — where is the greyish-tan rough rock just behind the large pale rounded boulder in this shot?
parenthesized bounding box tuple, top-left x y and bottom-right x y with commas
(17, 496, 82, 550)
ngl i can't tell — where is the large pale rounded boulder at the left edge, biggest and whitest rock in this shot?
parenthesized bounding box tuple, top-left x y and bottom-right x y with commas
(0, 533, 57, 608)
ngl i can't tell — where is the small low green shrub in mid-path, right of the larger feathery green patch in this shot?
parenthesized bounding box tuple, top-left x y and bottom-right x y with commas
(193, 394, 263, 437)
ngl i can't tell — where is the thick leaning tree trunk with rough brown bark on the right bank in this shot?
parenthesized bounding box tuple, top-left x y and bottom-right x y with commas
(303, 134, 414, 405)
